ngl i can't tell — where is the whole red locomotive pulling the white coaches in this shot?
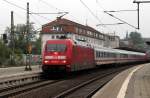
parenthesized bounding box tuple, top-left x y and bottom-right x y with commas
(42, 39, 95, 72)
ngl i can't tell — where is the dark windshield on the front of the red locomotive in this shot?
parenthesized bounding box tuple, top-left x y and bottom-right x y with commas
(46, 44, 67, 52)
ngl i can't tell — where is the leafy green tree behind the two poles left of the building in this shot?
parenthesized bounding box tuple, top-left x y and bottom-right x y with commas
(2, 24, 36, 64)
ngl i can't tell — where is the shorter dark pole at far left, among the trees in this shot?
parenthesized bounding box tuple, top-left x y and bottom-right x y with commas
(10, 11, 15, 64)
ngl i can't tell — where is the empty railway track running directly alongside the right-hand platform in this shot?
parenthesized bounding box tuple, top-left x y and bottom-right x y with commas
(54, 66, 124, 98)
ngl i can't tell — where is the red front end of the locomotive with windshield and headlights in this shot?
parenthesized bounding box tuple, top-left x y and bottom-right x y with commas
(42, 40, 71, 72)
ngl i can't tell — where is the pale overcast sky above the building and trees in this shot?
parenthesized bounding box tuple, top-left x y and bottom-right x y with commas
(0, 0, 150, 38)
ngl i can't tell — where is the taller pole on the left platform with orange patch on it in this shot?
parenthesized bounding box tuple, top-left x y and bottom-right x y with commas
(25, 2, 32, 71)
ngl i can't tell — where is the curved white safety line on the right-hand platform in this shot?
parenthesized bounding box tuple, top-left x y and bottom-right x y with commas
(117, 65, 144, 98)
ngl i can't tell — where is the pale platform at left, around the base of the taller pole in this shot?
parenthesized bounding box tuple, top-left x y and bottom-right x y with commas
(0, 65, 42, 78)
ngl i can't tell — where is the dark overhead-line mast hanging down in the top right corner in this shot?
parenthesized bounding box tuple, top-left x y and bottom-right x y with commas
(133, 0, 150, 29)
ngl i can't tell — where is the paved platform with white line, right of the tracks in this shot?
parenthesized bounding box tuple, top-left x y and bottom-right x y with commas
(92, 63, 150, 98)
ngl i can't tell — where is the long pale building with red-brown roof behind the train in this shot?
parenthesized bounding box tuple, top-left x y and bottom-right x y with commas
(41, 18, 119, 51)
